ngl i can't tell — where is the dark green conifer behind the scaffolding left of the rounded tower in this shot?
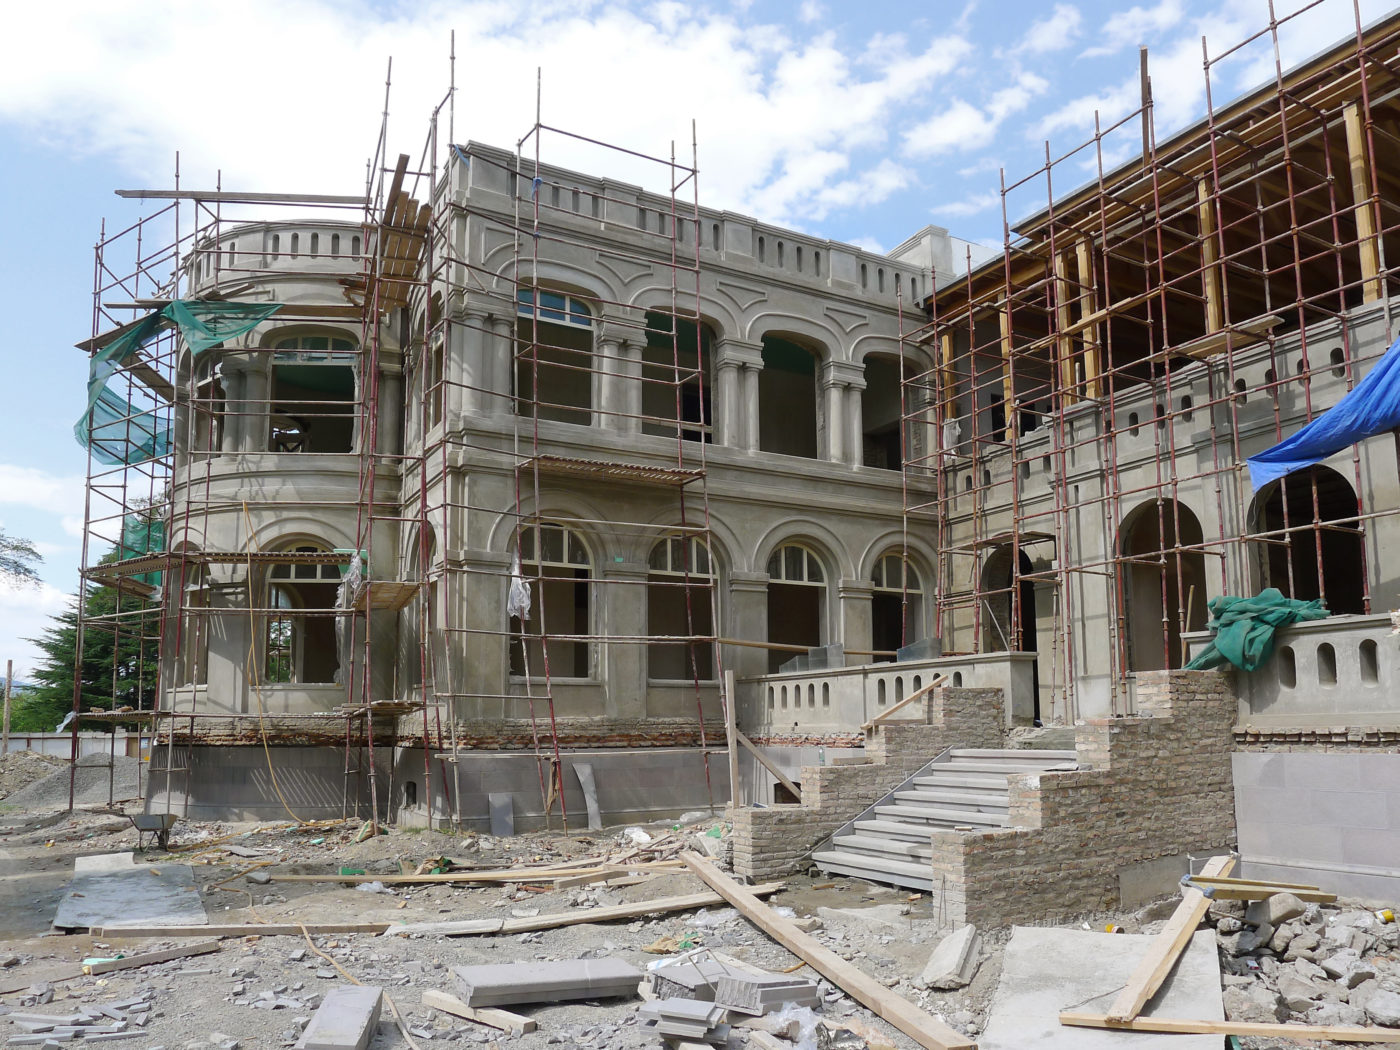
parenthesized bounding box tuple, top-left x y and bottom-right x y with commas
(13, 562, 160, 732)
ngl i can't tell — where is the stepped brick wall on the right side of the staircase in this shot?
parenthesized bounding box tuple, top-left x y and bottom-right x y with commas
(932, 671, 1238, 925)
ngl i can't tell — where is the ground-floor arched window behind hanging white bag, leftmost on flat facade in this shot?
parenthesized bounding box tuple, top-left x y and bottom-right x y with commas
(511, 522, 592, 678)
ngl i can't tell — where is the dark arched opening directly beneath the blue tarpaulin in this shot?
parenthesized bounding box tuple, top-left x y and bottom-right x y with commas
(1249, 466, 1366, 615)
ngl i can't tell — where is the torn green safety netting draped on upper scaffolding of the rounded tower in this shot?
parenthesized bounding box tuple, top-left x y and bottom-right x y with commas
(73, 300, 281, 466)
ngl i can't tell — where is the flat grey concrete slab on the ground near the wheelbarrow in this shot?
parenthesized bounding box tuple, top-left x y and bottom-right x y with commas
(53, 853, 209, 930)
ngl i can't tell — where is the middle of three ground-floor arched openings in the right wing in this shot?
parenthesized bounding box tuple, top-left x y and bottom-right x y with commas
(1119, 500, 1208, 671)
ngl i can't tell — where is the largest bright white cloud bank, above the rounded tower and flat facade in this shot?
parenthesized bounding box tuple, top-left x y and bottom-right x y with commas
(0, 0, 970, 223)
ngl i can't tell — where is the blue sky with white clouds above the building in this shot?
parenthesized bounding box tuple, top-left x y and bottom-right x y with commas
(0, 0, 1394, 679)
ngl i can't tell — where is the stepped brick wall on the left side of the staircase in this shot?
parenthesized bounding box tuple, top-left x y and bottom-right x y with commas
(731, 689, 1004, 879)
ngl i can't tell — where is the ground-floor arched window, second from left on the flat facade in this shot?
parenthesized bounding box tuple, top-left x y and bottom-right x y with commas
(647, 536, 715, 682)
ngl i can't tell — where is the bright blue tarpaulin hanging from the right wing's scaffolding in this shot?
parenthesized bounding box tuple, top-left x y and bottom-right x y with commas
(1249, 339, 1400, 490)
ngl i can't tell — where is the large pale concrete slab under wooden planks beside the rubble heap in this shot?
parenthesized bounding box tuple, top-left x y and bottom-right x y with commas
(977, 927, 1225, 1050)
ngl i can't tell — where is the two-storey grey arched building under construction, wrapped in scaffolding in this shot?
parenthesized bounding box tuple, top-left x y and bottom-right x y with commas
(71, 4, 1400, 901)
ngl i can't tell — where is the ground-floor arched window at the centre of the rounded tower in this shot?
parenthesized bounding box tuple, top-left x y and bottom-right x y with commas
(263, 545, 340, 685)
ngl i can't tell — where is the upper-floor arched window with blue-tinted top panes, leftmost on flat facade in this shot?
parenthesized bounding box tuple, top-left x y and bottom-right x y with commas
(515, 288, 594, 427)
